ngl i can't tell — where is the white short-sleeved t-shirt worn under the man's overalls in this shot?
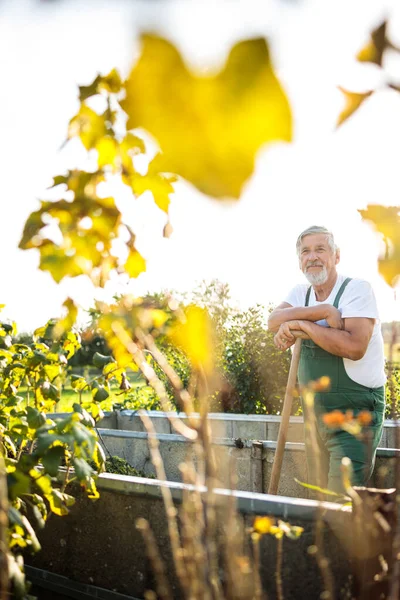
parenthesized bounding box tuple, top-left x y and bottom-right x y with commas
(285, 275, 386, 388)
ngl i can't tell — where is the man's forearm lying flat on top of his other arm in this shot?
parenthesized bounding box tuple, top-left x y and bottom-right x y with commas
(268, 302, 343, 332)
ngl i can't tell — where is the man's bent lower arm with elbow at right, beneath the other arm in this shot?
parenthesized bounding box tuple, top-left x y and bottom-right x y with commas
(291, 317, 375, 360)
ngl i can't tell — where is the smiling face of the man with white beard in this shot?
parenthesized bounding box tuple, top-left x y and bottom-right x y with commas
(299, 233, 339, 285)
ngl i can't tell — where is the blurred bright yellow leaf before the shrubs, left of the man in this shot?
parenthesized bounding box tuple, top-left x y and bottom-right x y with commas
(169, 305, 214, 374)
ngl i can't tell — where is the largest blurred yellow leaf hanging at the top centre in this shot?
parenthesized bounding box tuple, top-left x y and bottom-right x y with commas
(121, 34, 292, 198)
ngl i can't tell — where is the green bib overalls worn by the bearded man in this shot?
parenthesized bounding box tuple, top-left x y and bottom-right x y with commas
(298, 279, 385, 492)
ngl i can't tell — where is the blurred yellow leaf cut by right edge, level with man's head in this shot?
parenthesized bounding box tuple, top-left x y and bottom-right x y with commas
(358, 204, 400, 287)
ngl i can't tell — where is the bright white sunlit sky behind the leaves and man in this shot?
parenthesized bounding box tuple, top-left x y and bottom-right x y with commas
(0, 0, 400, 330)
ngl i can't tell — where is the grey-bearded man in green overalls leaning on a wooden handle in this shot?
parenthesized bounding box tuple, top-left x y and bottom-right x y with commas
(268, 226, 386, 491)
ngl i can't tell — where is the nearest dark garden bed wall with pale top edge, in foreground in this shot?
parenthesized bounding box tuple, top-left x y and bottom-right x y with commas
(26, 474, 352, 600)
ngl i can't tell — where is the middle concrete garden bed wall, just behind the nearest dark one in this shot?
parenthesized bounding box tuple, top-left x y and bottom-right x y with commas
(99, 429, 400, 498)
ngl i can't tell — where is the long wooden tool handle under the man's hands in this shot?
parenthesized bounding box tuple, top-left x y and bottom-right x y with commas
(268, 338, 301, 494)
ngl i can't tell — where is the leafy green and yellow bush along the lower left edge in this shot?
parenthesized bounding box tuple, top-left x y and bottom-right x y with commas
(0, 321, 104, 598)
